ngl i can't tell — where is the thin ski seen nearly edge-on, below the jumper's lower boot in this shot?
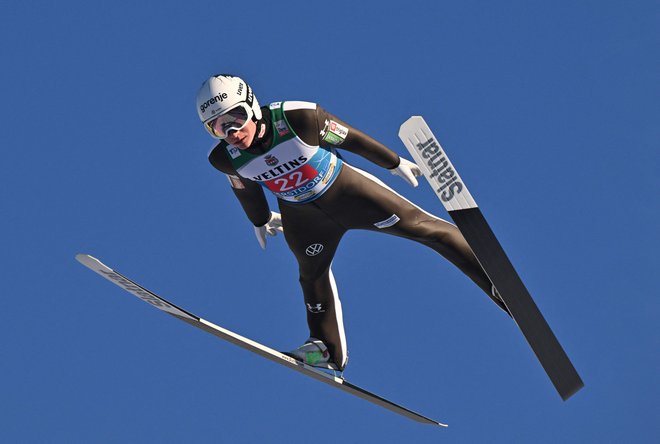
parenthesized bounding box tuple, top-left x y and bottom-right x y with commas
(76, 254, 447, 427)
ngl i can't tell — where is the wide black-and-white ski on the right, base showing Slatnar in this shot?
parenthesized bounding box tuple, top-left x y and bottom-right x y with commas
(399, 116, 584, 400)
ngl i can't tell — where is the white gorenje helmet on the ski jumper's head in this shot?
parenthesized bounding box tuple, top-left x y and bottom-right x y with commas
(197, 74, 262, 139)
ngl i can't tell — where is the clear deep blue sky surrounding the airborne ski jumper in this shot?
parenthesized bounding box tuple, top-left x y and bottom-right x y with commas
(0, 1, 660, 443)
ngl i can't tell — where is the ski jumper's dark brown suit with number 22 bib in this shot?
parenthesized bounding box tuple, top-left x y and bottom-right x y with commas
(209, 101, 504, 370)
